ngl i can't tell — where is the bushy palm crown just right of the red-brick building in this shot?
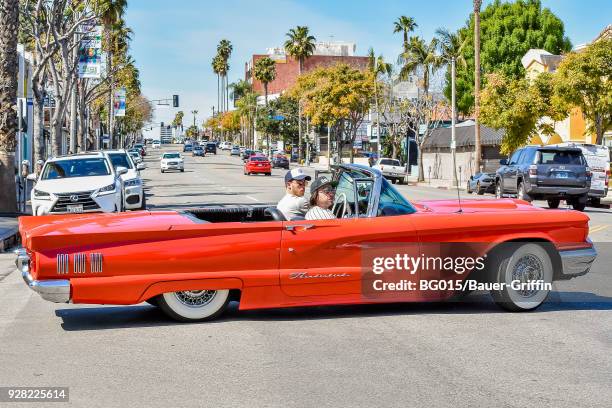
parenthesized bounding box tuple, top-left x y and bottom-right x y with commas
(398, 36, 441, 95)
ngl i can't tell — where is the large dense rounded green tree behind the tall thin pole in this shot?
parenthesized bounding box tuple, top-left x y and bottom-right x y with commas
(444, 0, 571, 115)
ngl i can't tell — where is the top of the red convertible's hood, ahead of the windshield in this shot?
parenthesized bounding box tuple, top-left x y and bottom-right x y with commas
(413, 199, 544, 213)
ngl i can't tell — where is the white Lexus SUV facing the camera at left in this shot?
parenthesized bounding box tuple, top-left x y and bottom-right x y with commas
(28, 153, 128, 215)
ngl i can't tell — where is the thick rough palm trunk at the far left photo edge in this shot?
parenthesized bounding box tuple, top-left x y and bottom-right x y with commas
(0, 0, 19, 212)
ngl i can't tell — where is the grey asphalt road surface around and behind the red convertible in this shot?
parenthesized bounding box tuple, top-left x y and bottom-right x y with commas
(0, 145, 612, 407)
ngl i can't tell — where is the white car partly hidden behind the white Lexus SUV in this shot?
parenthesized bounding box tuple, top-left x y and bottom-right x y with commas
(104, 149, 147, 210)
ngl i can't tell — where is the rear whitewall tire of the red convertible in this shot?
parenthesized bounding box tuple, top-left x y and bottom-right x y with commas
(157, 290, 230, 322)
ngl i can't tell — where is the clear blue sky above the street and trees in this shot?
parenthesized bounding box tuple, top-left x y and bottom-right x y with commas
(126, 0, 612, 134)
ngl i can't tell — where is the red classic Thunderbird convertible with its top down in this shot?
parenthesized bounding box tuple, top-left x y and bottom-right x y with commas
(16, 165, 596, 321)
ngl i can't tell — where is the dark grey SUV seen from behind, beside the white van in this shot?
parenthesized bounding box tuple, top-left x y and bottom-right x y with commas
(495, 146, 591, 211)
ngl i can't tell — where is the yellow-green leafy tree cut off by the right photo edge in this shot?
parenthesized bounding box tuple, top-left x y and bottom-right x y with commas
(554, 39, 612, 144)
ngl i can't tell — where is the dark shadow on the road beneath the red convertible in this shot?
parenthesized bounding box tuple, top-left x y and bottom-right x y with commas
(55, 292, 612, 331)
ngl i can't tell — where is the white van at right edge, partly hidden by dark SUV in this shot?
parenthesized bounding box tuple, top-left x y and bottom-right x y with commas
(555, 142, 610, 206)
